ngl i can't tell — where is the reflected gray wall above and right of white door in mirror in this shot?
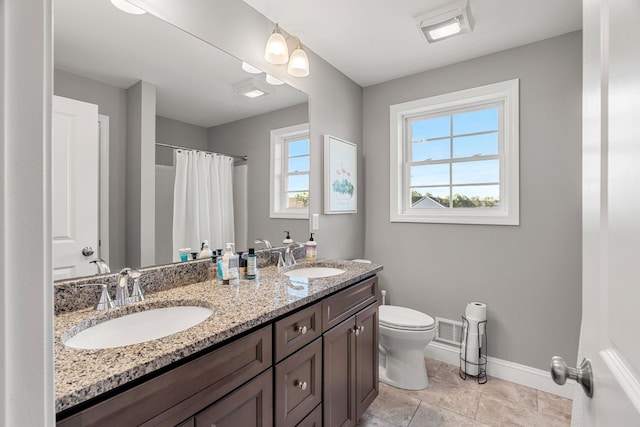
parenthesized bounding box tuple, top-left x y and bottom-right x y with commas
(53, 70, 127, 268)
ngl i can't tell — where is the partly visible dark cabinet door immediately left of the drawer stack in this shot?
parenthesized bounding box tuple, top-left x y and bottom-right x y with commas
(195, 369, 273, 427)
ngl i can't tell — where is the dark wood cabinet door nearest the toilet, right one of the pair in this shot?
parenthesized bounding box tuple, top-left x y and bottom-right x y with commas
(356, 304, 378, 419)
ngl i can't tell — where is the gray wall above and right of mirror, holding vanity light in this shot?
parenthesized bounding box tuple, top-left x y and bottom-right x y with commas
(131, 0, 364, 258)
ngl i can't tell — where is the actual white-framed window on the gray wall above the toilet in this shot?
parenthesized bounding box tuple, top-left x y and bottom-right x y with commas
(391, 80, 519, 225)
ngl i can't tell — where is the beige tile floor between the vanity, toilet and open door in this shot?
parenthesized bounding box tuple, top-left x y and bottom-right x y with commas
(358, 359, 571, 427)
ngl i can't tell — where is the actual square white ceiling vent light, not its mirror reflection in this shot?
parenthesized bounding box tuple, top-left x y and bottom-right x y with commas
(416, 0, 473, 43)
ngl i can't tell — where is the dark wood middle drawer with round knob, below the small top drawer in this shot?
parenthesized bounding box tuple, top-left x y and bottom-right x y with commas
(275, 339, 322, 427)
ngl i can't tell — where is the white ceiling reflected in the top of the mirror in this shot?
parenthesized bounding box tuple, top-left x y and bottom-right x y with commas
(53, 0, 308, 127)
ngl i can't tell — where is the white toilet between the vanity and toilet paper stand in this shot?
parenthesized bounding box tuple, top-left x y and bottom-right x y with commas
(379, 305, 436, 390)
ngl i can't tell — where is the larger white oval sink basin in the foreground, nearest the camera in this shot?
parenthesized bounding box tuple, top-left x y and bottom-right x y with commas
(63, 306, 213, 350)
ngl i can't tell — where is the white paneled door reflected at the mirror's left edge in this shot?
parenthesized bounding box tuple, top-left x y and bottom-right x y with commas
(51, 96, 99, 280)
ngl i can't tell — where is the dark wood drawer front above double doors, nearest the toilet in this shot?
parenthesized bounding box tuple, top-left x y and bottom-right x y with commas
(322, 277, 378, 331)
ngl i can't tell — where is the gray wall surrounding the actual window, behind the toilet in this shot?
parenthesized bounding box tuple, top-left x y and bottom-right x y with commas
(363, 32, 582, 370)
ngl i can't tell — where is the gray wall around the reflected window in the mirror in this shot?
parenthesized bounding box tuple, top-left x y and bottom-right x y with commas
(208, 104, 309, 247)
